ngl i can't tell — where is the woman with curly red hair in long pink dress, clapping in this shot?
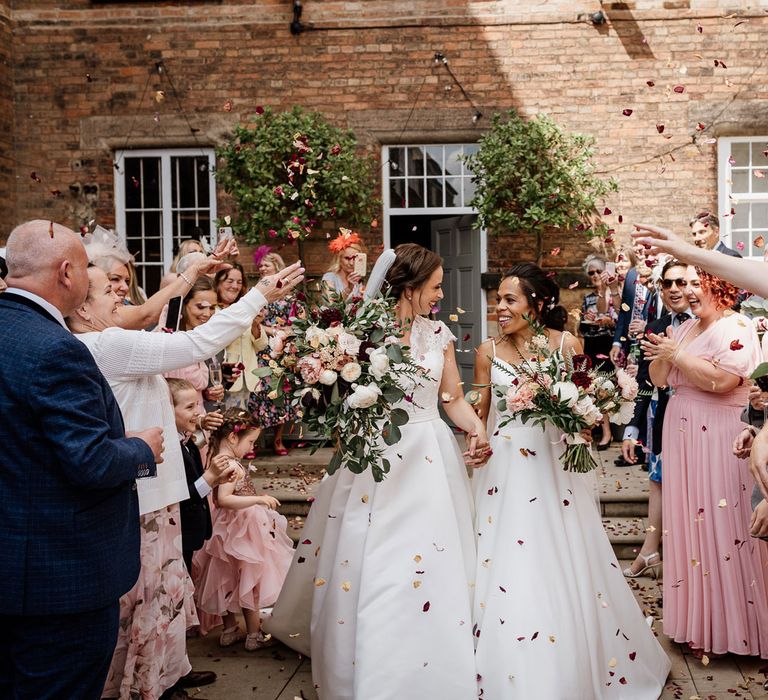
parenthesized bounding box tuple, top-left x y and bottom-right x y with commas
(642, 267, 768, 658)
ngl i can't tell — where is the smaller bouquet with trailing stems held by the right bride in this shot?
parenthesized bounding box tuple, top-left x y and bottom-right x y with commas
(492, 326, 638, 473)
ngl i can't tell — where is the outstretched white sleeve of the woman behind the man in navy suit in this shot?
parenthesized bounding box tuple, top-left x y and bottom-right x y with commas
(77, 288, 267, 379)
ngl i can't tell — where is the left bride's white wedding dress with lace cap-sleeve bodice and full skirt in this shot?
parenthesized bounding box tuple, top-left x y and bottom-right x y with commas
(265, 317, 476, 700)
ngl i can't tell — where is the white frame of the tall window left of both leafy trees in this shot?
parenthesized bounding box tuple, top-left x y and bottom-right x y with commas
(114, 147, 217, 272)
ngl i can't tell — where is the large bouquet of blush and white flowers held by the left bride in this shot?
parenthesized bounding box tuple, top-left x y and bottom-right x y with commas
(256, 295, 423, 481)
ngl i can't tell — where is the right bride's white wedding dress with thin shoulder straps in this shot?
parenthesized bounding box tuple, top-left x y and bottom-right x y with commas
(473, 347, 670, 700)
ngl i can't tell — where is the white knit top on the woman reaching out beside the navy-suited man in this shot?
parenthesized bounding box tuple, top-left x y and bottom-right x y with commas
(76, 288, 267, 515)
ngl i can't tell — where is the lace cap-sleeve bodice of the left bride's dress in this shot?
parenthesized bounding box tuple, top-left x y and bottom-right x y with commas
(399, 316, 456, 422)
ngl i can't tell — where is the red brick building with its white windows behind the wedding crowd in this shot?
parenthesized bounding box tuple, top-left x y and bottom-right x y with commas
(0, 0, 768, 350)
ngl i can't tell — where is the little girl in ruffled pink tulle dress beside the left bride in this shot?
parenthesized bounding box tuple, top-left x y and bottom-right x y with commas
(195, 409, 293, 651)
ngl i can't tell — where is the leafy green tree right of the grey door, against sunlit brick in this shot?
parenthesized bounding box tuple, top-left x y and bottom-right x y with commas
(464, 110, 617, 252)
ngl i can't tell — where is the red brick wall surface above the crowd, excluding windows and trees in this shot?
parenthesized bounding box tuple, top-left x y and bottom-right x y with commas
(0, 0, 768, 318)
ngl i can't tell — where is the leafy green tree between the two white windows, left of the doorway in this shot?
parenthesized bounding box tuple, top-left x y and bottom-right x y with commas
(216, 107, 379, 243)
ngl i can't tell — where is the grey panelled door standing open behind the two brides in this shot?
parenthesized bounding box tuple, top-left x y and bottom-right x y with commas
(432, 214, 483, 393)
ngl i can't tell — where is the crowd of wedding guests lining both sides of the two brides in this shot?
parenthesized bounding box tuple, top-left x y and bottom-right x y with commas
(0, 213, 768, 700)
